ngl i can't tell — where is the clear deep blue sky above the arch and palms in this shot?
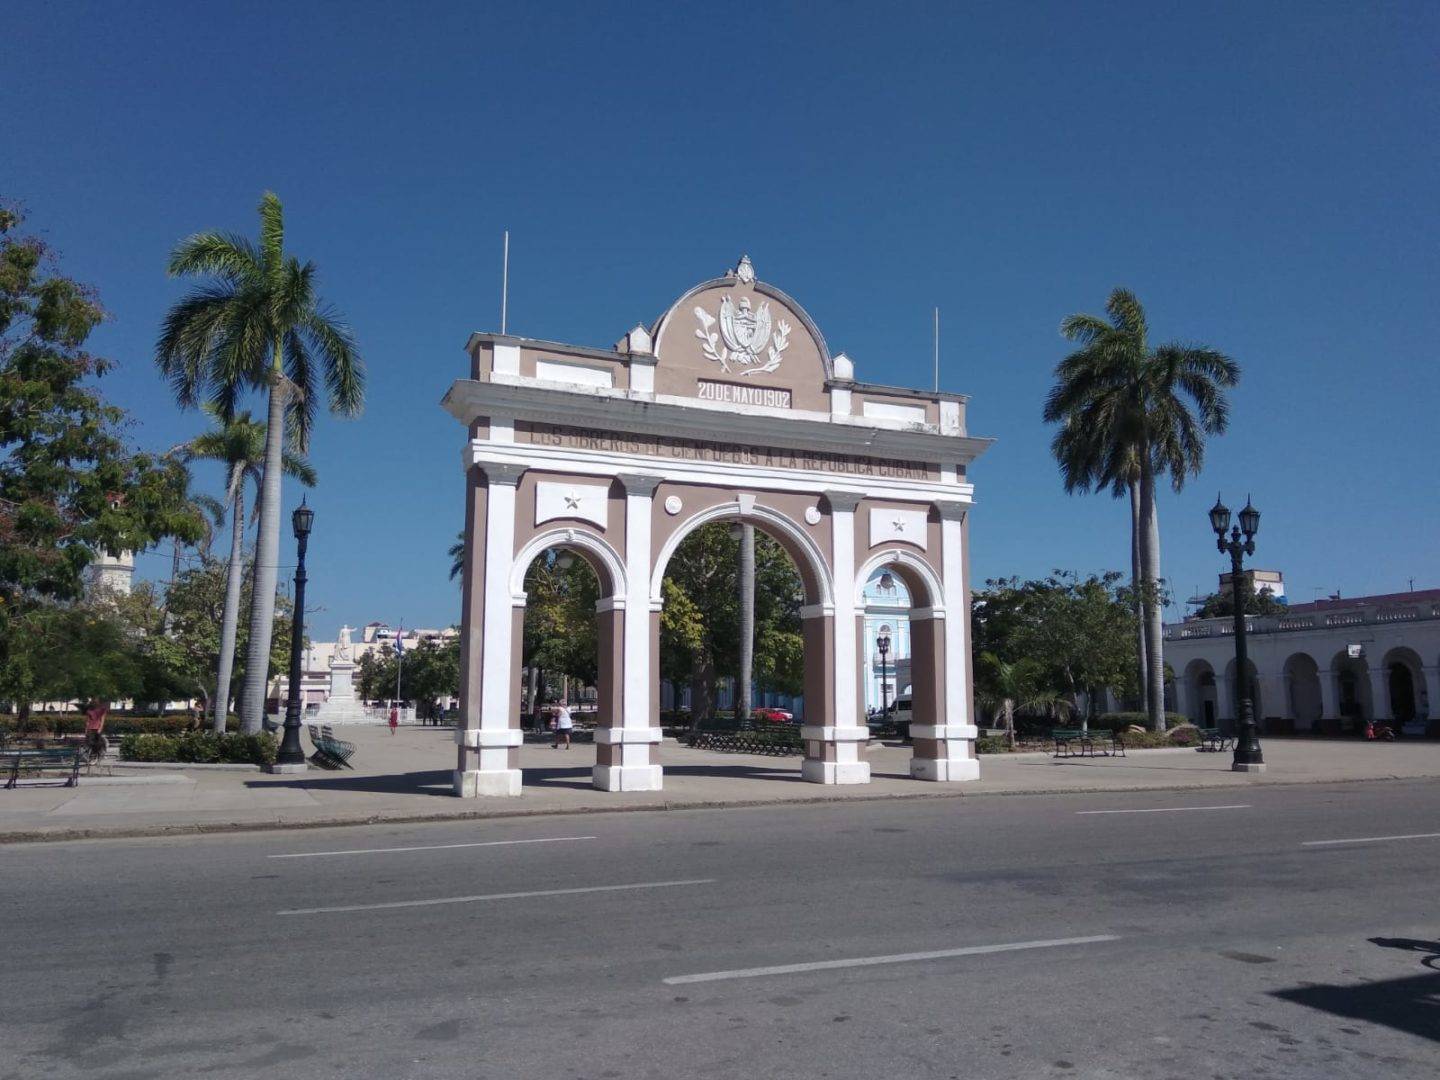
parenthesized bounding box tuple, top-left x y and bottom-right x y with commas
(0, 0, 1440, 635)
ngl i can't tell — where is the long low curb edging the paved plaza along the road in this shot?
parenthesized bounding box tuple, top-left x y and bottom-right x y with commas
(0, 773, 1422, 845)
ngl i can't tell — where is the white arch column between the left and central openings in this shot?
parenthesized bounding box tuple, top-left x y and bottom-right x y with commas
(595, 474, 664, 791)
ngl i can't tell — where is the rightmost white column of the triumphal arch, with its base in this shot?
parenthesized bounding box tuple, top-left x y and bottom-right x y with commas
(910, 503, 981, 780)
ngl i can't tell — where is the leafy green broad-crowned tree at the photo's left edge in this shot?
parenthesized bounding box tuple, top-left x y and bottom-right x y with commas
(0, 207, 204, 714)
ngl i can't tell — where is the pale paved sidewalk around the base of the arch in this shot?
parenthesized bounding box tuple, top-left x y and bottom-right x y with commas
(0, 727, 1440, 842)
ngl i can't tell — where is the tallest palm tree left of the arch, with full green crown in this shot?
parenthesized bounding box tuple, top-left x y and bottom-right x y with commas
(156, 192, 364, 733)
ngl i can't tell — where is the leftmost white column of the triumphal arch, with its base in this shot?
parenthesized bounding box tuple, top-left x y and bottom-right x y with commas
(455, 462, 524, 798)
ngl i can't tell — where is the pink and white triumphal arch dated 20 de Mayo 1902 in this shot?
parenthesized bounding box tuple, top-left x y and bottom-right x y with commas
(444, 259, 989, 796)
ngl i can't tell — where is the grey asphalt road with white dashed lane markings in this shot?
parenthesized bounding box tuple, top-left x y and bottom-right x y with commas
(0, 782, 1440, 1080)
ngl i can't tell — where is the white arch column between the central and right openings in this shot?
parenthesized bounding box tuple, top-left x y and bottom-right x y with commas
(801, 491, 870, 783)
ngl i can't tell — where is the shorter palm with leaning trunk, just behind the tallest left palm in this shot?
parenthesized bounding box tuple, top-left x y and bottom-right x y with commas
(171, 403, 315, 732)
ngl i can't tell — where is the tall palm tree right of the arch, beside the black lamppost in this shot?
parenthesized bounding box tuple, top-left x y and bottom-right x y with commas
(1044, 288, 1240, 732)
